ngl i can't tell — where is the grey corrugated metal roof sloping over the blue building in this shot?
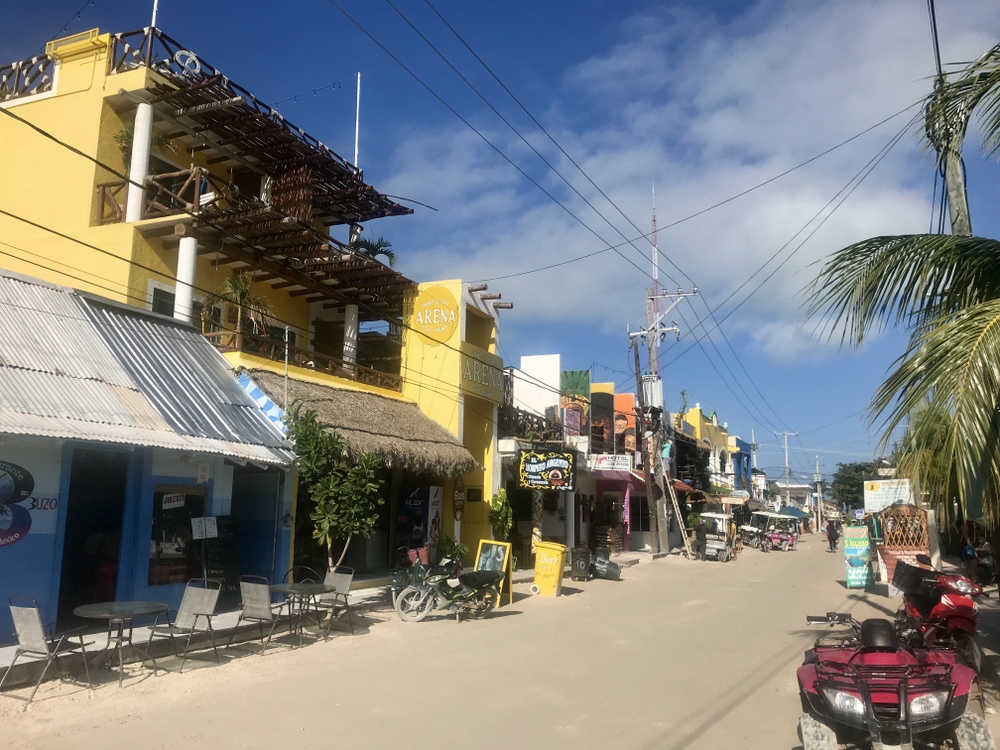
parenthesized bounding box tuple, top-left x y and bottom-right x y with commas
(0, 272, 292, 465)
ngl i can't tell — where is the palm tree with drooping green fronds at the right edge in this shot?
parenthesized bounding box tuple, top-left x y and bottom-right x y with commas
(806, 45, 1000, 519)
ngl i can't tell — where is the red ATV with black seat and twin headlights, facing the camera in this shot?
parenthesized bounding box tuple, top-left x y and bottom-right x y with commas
(798, 612, 996, 750)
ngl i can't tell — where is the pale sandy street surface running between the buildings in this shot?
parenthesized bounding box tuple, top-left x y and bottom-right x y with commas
(0, 535, 1000, 750)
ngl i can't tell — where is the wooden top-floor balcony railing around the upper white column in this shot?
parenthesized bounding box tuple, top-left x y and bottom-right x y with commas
(97, 167, 248, 224)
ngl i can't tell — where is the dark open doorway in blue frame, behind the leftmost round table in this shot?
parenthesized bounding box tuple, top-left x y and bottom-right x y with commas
(58, 448, 129, 628)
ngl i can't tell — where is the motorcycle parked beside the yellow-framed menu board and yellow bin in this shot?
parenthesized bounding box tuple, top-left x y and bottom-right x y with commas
(395, 558, 505, 622)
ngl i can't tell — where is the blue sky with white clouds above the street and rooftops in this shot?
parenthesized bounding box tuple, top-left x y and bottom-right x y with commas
(0, 0, 1000, 479)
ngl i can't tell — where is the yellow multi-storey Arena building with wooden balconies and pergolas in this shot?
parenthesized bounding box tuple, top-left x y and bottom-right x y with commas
(0, 29, 502, 567)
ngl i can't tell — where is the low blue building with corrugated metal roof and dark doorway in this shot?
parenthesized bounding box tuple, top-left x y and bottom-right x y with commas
(0, 271, 294, 642)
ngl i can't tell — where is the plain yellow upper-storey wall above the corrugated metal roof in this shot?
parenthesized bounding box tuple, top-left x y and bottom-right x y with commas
(0, 34, 309, 338)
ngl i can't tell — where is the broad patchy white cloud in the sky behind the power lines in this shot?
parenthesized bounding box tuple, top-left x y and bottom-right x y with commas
(380, 0, 1000, 368)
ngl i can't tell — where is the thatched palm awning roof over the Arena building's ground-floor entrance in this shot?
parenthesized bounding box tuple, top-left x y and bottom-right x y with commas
(246, 370, 476, 477)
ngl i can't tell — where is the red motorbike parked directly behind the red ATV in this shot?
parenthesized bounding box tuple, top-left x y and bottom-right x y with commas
(892, 555, 986, 661)
